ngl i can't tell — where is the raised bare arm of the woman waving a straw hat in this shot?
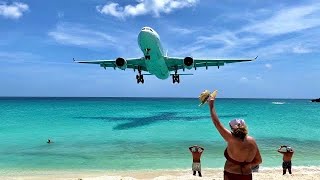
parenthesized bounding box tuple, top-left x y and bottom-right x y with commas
(208, 97, 232, 142)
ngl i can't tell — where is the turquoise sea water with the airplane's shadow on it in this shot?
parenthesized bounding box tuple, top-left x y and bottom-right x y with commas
(0, 98, 320, 170)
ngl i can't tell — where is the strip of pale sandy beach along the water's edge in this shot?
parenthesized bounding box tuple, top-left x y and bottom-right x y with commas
(0, 166, 320, 180)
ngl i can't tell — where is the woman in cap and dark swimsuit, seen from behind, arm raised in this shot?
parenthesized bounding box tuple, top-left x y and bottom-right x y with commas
(208, 93, 262, 180)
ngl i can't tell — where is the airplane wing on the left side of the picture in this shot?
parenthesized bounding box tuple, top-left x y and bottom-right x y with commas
(73, 58, 147, 71)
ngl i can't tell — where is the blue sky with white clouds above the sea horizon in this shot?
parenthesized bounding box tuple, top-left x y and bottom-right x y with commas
(0, 0, 320, 99)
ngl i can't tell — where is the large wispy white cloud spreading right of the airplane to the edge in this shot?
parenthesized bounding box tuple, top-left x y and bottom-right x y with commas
(176, 3, 320, 58)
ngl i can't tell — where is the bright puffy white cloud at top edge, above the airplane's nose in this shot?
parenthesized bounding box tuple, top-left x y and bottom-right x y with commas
(96, 0, 199, 19)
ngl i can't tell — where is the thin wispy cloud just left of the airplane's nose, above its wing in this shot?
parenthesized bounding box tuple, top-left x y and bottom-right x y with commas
(48, 22, 142, 57)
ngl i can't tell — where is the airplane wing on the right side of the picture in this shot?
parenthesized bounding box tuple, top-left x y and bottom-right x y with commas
(166, 56, 258, 71)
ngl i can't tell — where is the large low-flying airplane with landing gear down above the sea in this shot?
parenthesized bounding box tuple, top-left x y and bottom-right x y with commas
(73, 27, 258, 84)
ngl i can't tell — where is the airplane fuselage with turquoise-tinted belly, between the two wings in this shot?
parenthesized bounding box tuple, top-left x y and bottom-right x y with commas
(138, 27, 170, 79)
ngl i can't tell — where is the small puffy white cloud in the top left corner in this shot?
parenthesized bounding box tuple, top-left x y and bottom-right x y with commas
(0, 2, 29, 19)
